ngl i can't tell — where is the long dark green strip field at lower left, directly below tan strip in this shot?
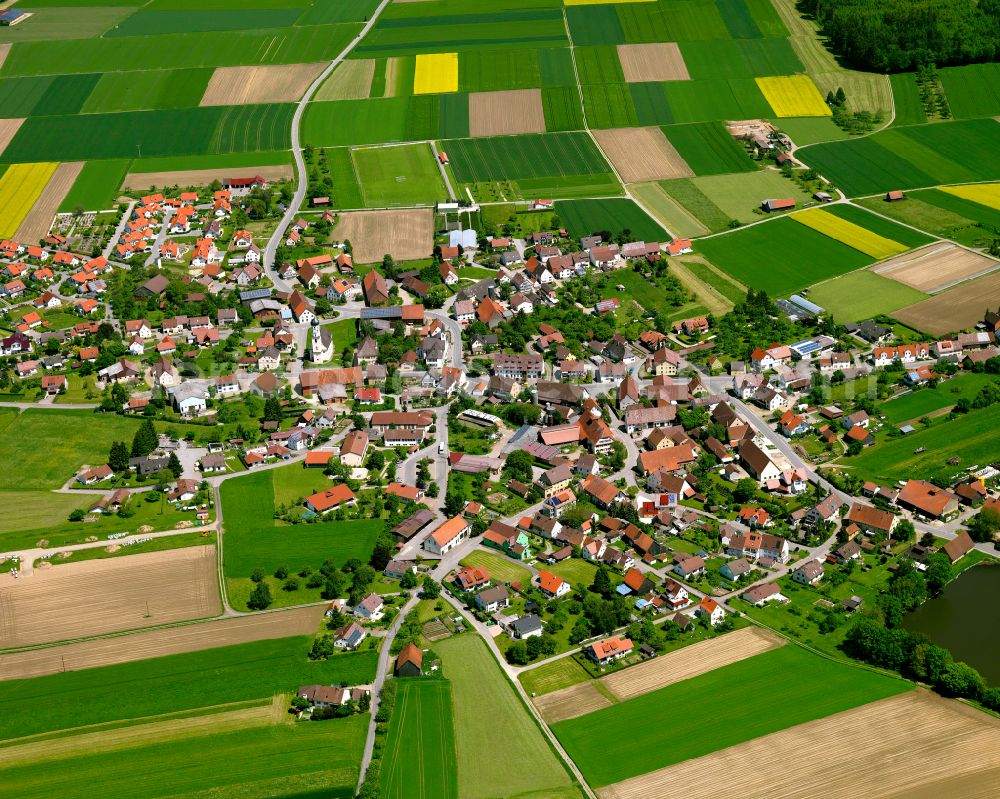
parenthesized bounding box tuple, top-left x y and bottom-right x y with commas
(0, 636, 378, 740)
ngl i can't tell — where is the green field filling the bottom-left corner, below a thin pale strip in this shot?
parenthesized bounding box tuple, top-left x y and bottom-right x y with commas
(0, 714, 368, 799)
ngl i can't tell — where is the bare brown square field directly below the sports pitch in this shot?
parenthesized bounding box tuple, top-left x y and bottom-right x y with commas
(334, 208, 434, 264)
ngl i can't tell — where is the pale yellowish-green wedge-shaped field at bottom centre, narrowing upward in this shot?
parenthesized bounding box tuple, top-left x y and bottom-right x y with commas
(434, 634, 580, 799)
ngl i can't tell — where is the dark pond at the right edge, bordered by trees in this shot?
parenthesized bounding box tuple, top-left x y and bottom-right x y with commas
(903, 565, 1000, 685)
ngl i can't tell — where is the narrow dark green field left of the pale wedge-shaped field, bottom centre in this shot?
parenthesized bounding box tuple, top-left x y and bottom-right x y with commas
(380, 679, 458, 799)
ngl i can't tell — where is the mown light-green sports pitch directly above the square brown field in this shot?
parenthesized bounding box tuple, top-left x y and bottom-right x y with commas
(351, 144, 447, 208)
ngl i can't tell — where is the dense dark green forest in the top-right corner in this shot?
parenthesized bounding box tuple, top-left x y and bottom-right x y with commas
(798, 0, 1000, 72)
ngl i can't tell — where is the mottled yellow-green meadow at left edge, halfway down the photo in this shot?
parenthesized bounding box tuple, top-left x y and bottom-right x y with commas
(0, 408, 139, 491)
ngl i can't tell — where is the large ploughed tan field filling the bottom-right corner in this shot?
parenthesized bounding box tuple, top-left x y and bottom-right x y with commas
(598, 690, 1000, 799)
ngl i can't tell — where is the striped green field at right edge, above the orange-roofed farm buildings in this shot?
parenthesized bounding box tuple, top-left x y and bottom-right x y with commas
(847, 405, 1000, 483)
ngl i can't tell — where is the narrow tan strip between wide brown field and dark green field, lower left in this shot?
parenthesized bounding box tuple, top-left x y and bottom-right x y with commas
(0, 608, 324, 680)
